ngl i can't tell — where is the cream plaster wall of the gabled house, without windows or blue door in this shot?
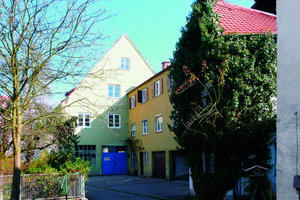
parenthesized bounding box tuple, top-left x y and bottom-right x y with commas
(62, 35, 154, 175)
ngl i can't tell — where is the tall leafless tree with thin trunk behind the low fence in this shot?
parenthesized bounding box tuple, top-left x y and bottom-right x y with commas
(0, 0, 109, 199)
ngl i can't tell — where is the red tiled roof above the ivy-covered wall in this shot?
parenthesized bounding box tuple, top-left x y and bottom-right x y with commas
(214, 0, 277, 34)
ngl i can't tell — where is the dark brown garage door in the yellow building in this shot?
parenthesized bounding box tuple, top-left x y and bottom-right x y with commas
(153, 151, 166, 178)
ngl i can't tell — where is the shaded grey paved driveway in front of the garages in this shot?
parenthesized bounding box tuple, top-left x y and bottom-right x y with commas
(86, 175, 189, 200)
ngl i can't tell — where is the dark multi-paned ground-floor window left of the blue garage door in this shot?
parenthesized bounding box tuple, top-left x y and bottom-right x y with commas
(75, 145, 96, 166)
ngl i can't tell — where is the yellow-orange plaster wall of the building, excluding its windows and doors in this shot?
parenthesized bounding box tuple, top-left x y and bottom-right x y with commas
(128, 70, 178, 179)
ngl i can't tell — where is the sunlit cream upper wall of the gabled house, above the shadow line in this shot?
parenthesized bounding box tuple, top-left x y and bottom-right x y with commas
(63, 35, 154, 117)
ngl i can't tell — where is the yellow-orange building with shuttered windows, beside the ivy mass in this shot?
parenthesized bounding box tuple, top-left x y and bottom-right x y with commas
(127, 62, 188, 180)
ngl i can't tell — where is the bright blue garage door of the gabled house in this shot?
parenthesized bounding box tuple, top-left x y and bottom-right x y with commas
(102, 146, 127, 175)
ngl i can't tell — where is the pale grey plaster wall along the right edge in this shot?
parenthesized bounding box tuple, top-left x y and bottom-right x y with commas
(276, 0, 300, 200)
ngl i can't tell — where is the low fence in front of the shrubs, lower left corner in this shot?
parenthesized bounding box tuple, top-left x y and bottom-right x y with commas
(0, 173, 85, 200)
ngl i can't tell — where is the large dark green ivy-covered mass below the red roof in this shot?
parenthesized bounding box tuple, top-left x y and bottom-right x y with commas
(170, 0, 276, 200)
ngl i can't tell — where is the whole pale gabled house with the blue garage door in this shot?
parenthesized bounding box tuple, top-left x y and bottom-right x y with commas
(61, 34, 155, 175)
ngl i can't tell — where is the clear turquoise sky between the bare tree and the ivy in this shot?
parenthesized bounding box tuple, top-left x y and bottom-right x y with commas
(53, 0, 254, 103)
